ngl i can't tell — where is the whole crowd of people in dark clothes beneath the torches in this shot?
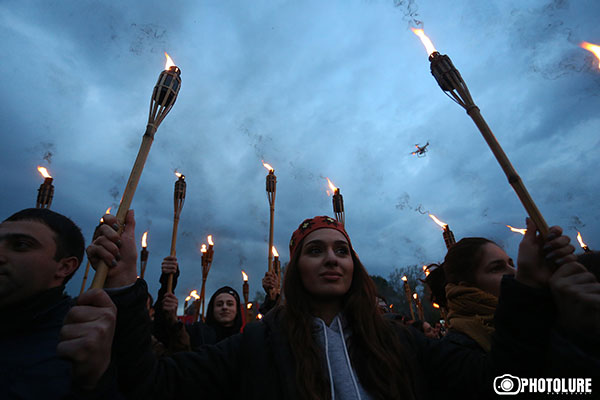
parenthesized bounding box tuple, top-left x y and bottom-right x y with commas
(0, 209, 600, 400)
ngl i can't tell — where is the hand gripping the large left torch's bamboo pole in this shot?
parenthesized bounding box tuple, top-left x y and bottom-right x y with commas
(87, 210, 137, 288)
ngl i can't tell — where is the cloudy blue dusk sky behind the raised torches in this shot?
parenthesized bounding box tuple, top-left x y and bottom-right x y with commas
(0, 0, 600, 301)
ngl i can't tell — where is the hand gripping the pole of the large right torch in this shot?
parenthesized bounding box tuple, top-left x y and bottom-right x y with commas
(516, 218, 575, 287)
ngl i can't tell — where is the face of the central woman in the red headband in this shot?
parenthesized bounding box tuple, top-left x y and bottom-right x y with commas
(298, 228, 354, 300)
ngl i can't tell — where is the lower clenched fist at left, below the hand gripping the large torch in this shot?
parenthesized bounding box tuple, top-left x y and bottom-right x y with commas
(57, 289, 117, 390)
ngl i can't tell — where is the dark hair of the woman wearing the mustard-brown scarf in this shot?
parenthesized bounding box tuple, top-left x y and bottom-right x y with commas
(425, 237, 496, 307)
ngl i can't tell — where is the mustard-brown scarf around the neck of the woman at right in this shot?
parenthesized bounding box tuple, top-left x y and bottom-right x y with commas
(446, 283, 498, 352)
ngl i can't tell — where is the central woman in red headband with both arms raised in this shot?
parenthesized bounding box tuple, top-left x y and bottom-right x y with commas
(63, 212, 584, 400)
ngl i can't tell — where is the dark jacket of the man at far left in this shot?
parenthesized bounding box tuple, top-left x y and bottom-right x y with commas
(0, 286, 73, 399)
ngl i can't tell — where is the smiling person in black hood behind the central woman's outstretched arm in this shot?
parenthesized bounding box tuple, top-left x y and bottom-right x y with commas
(186, 286, 244, 349)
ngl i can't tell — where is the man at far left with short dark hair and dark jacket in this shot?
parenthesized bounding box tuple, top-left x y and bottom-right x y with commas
(0, 208, 116, 399)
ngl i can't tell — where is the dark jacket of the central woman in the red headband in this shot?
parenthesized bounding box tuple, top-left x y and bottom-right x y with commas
(108, 279, 551, 400)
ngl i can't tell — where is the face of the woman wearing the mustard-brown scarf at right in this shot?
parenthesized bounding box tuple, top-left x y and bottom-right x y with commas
(475, 243, 515, 297)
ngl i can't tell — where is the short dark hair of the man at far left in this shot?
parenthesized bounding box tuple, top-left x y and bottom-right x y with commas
(4, 208, 85, 285)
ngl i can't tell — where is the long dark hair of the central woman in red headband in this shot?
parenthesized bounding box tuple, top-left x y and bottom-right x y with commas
(283, 234, 415, 400)
